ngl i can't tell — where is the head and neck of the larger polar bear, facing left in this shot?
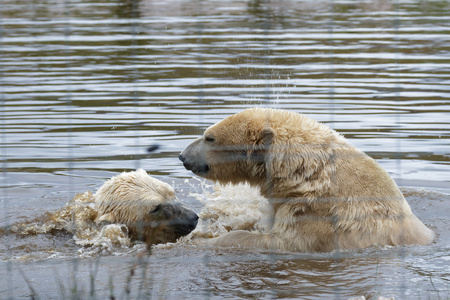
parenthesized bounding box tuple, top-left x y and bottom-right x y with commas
(179, 108, 346, 196)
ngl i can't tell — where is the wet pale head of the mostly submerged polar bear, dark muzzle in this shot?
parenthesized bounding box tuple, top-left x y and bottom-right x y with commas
(94, 169, 198, 246)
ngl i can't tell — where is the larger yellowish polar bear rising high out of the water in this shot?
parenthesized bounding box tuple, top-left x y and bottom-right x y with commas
(179, 108, 434, 252)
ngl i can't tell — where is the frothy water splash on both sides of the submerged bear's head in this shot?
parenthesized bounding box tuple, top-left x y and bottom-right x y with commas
(7, 179, 272, 257)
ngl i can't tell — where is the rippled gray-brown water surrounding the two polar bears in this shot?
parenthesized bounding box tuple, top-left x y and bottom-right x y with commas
(0, 0, 450, 299)
